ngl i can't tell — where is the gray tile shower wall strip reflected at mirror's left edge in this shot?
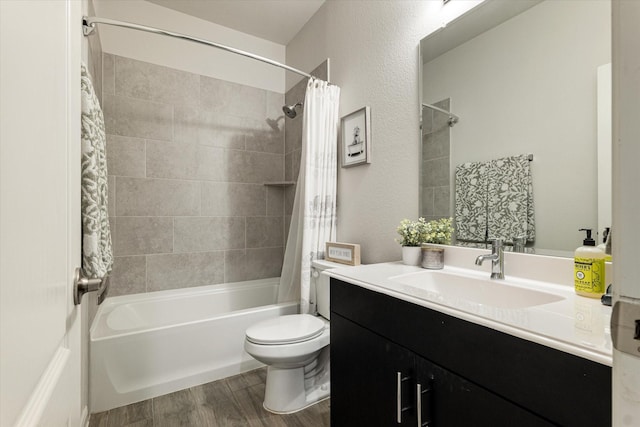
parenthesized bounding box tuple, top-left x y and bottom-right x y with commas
(420, 99, 452, 221)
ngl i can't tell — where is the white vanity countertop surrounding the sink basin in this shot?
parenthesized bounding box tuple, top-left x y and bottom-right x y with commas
(326, 254, 612, 366)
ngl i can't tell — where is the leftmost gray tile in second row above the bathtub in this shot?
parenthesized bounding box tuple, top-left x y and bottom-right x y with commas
(113, 216, 173, 256)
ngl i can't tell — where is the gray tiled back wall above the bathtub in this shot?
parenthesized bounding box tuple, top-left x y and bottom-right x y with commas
(103, 54, 286, 295)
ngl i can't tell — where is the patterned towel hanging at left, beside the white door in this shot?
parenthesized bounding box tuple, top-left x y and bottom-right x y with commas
(81, 64, 113, 278)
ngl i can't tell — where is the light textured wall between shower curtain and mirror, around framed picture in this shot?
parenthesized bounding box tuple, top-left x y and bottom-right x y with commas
(287, 1, 477, 263)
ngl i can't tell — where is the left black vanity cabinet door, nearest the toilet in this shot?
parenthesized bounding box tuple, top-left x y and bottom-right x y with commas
(331, 313, 415, 427)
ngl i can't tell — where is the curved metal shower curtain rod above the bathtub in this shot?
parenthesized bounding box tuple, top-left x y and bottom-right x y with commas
(82, 16, 316, 78)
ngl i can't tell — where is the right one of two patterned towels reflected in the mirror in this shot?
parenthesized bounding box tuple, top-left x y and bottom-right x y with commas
(487, 154, 536, 242)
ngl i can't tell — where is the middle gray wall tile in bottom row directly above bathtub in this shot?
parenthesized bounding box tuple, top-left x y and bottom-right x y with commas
(147, 251, 224, 292)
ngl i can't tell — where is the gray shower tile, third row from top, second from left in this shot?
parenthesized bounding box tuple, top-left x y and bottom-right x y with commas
(146, 140, 198, 179)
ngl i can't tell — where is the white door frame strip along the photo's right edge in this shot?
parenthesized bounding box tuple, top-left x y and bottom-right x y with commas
(612, 0, 640, 427)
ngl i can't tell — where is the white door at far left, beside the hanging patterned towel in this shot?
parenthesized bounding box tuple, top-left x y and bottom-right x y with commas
(0, 0, 82, 426)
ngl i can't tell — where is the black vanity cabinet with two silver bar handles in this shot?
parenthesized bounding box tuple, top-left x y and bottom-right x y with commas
(331, 279, 611, 427)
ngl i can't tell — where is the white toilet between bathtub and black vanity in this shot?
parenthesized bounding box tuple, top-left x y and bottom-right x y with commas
(244, 260, 345, 414)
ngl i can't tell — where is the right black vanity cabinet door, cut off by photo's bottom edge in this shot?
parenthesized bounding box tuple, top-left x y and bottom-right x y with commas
(416, 356, 554, 427)
